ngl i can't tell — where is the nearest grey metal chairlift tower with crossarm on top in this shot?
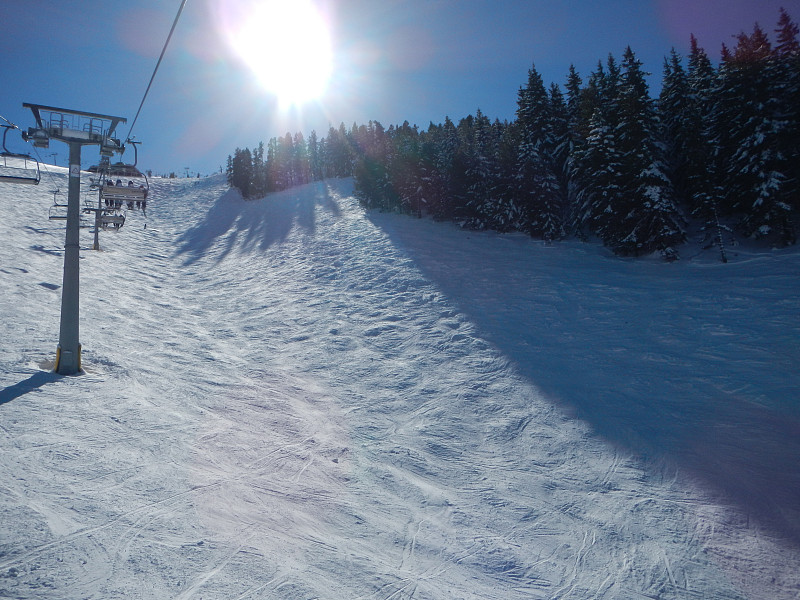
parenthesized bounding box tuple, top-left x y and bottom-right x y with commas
(22, 102, 127, 375)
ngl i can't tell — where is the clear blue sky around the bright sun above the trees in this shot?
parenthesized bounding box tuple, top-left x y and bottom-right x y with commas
(0, 0, 800, 174)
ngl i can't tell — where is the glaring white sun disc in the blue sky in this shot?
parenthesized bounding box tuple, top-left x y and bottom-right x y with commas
(223, 0, 333, 107)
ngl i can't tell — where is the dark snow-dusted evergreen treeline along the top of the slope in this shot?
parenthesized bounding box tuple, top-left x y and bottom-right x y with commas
(228, 9, 800, 259)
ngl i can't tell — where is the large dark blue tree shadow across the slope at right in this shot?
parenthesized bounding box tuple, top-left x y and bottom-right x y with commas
(370, 213, 800, 544)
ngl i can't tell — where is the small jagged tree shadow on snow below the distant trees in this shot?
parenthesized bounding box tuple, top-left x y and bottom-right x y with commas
(177, 181, 339, 264)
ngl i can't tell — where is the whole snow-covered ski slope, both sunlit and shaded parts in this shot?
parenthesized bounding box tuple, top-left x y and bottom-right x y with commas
(0, 167, 800, 600)
